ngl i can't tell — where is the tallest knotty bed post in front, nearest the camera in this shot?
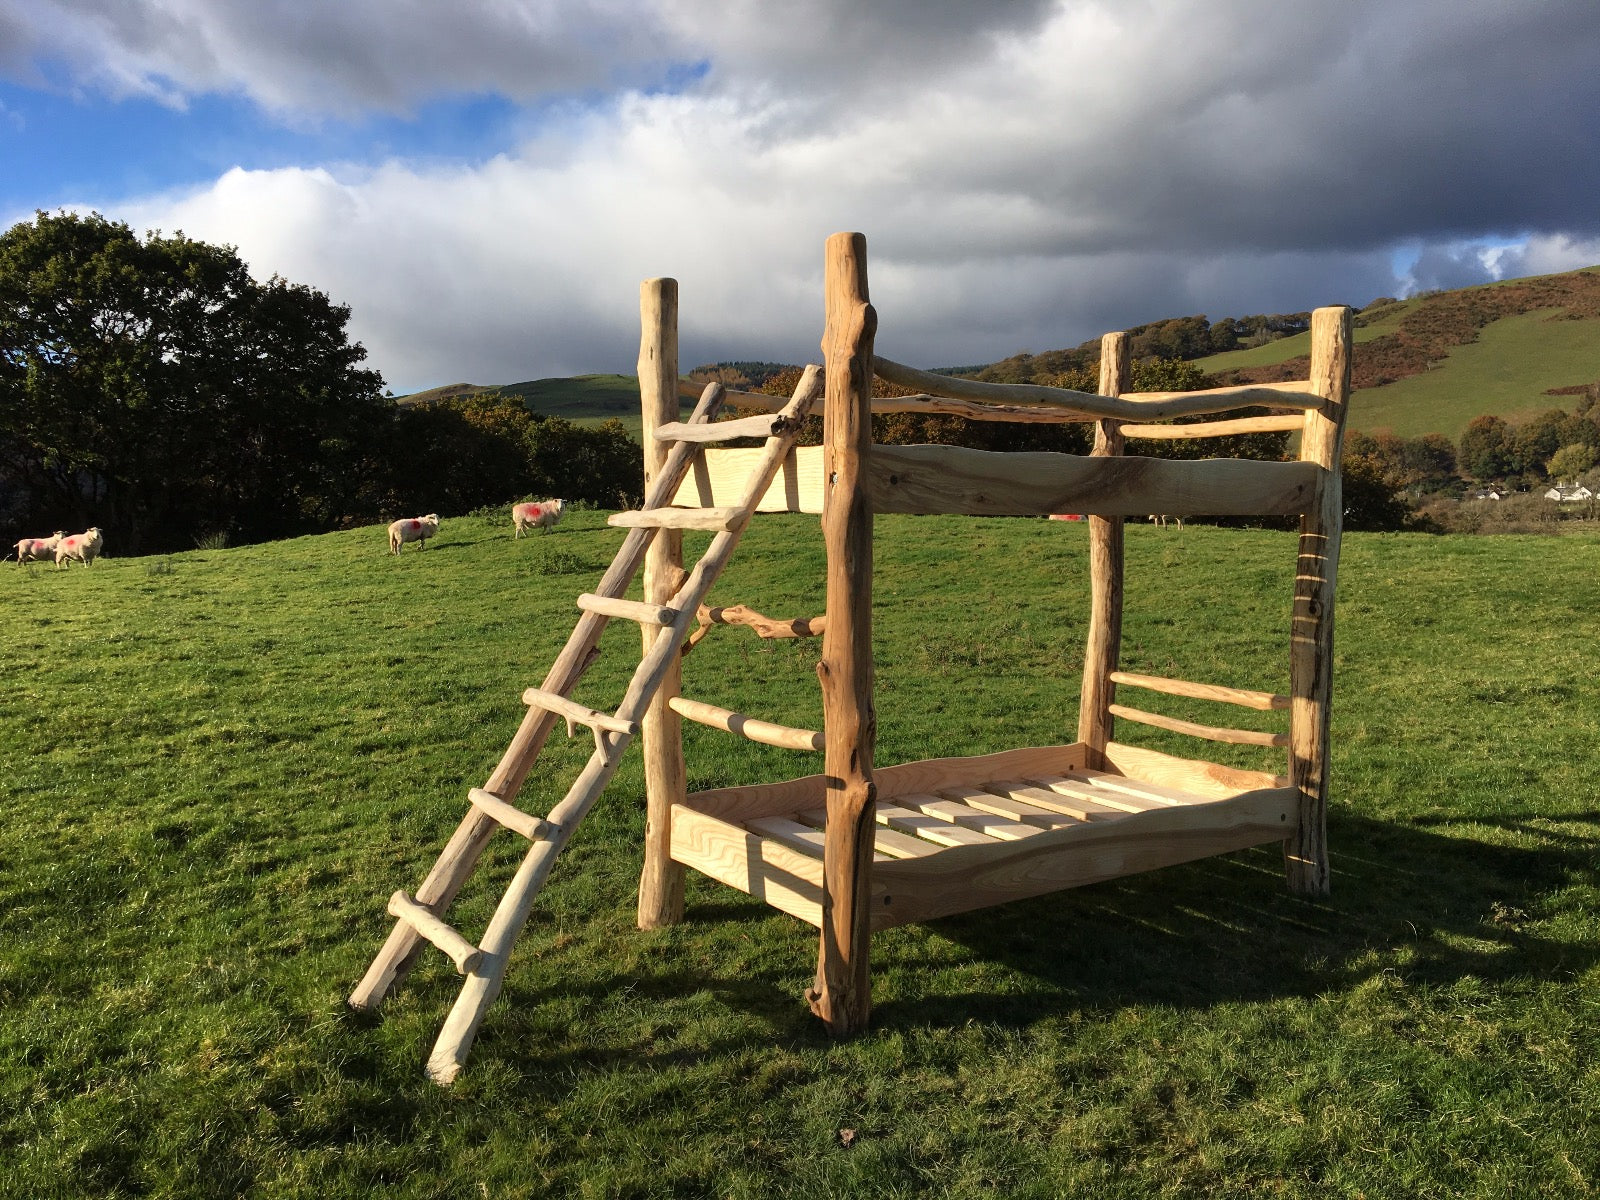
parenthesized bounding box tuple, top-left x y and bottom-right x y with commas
(806, 234, 878, 1034)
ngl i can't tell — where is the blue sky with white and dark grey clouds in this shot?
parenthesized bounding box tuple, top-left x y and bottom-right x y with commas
(0, 0, 1600, 394)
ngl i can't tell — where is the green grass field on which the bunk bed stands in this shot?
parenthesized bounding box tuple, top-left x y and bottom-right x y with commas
(0, 512, 1600, 1198)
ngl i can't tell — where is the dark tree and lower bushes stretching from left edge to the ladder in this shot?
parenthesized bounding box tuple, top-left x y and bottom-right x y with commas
(0, 213, 643, 554)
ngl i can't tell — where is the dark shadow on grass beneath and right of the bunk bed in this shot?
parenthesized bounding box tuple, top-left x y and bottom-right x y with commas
(874, 818, 1600, 1026)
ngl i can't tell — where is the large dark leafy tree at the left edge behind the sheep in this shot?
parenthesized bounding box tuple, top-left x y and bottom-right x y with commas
(0, 213, 394, 552)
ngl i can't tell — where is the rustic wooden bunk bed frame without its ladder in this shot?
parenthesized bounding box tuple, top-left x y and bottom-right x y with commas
(638, 234, 1350, 1034)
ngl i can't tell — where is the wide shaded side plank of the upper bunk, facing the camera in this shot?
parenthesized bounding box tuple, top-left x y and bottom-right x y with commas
(866, 446, 1323, 517)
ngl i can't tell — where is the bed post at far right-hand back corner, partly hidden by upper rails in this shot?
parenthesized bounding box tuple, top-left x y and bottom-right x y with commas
(1078, 333, 1131, 771)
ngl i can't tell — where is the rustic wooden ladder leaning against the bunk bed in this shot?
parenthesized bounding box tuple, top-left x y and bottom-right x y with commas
(349, 366, 822, 1085)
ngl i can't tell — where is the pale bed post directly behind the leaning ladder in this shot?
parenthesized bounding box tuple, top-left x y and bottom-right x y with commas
(638, 278, 688, 930)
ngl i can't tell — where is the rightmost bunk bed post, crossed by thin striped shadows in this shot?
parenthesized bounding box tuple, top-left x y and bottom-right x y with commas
(1283, 307, 1350, 896)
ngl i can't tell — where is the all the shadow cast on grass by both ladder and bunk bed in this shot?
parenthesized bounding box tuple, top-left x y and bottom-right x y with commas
(334, 818, 1600, 1099)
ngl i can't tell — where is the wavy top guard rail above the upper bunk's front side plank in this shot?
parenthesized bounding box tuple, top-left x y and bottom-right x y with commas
(872, 357, 1322, 421)
